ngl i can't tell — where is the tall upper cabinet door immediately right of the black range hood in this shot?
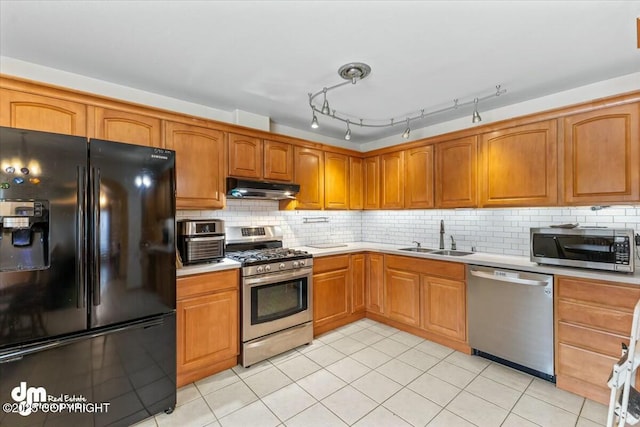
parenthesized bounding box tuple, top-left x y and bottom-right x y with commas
(293, 147, 324, 209)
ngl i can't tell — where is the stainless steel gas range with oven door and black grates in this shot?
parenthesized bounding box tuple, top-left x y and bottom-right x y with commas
(225, 226, 313, 367)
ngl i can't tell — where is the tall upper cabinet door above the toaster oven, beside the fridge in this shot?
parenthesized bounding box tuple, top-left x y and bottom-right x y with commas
(165, 122, 224, 209)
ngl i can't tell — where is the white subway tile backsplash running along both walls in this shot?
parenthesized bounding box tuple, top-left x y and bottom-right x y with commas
(178, 200, 640, 256)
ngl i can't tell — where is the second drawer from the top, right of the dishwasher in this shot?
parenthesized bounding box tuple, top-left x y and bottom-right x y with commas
(557, 300, 633, 335)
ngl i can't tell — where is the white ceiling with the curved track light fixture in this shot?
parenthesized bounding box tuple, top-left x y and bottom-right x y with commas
(0, 0, 640, 142)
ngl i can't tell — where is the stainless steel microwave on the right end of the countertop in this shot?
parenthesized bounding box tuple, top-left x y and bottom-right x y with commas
(530, 227, 635, 273)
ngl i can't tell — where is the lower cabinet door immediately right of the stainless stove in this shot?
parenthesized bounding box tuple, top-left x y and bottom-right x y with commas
(313, 268, 351, 328)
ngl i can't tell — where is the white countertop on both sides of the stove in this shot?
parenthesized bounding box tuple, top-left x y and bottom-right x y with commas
(177, 242, 640, 286)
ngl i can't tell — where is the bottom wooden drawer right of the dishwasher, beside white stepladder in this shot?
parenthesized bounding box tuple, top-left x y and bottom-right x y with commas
(556, 343, 619, 394)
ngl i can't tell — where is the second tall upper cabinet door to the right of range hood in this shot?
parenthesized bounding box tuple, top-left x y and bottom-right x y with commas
(324, 152, 349, 209)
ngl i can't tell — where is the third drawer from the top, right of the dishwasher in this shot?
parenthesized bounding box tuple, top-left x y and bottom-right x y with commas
(557, 322, 629, 357)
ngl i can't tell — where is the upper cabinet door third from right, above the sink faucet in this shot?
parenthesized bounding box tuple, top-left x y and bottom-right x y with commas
(435, 136, 478, 208)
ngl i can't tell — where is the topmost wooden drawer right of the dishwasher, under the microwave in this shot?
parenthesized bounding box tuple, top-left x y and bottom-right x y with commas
(557, 277, 640, 312)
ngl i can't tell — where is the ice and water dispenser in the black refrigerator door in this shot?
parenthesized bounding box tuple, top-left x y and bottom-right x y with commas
(0, 199, 50, 271)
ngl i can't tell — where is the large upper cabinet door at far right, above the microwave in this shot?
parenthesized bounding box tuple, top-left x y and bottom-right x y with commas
(563, 103, 640, 205)
